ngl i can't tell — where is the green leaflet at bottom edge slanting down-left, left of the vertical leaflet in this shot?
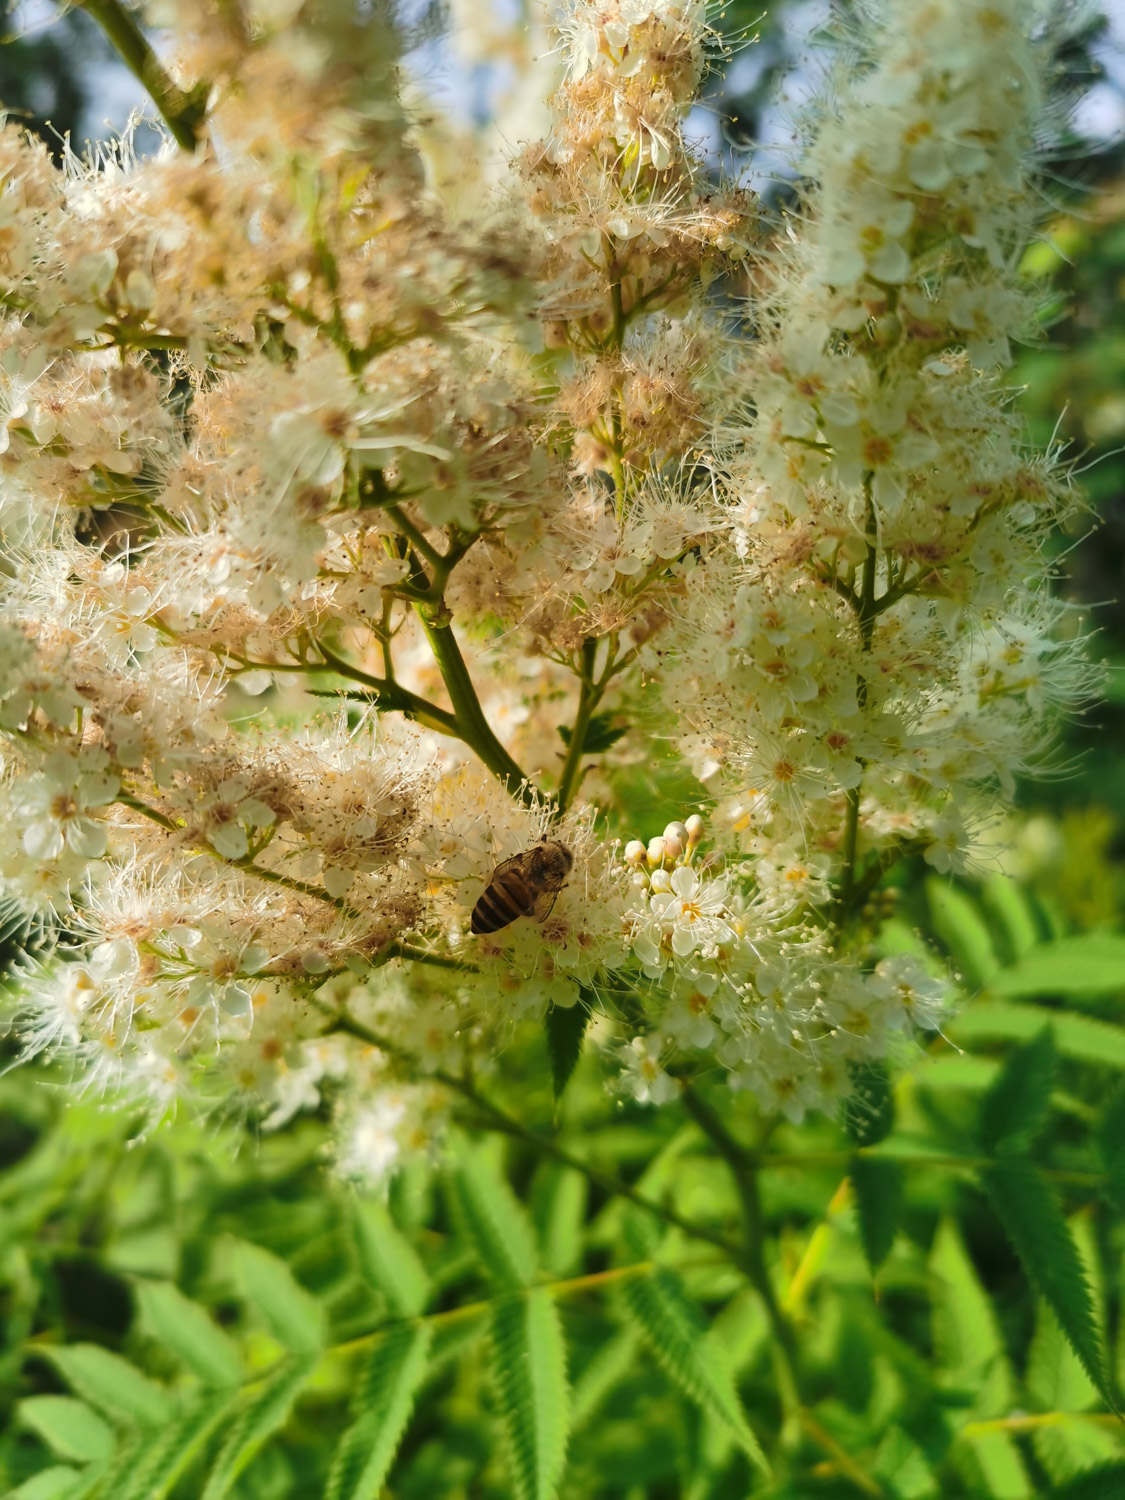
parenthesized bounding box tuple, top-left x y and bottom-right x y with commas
(326, 1325, 432, 1500)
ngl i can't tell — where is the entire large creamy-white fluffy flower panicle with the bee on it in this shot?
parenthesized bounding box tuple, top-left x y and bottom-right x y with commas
(0, 0, 1089, 1178)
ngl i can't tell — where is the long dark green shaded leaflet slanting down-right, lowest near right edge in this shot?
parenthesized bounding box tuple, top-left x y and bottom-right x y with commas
(981, 1161, 1115, 1406)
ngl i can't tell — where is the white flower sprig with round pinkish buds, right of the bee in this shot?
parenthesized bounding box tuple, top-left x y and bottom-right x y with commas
(624, 815, 948, 1121)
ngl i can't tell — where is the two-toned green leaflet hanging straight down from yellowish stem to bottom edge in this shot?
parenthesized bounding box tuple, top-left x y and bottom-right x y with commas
(489, 1287, 570, 1500)
